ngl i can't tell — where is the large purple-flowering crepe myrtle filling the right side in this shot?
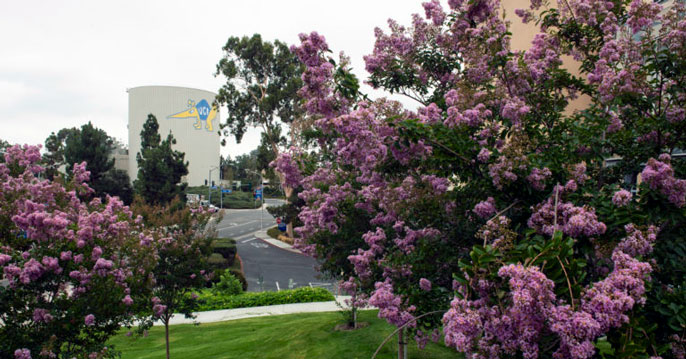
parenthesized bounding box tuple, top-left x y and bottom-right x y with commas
(274, 0, 686, 358)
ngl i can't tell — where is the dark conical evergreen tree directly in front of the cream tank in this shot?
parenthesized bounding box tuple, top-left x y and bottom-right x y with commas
(134, 114, 188, 204)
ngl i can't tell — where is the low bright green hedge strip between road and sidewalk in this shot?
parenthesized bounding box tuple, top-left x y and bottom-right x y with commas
(198, 287, 335, 311)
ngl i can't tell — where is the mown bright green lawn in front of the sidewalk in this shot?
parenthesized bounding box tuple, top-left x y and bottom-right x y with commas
(109, 311, 462, 359)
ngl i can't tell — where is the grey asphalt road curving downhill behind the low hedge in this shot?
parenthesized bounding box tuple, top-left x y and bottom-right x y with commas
(217, 200, 331, 291)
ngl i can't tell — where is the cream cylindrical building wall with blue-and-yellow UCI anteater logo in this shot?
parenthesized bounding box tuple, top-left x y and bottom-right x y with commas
(127, 86, 220, 186)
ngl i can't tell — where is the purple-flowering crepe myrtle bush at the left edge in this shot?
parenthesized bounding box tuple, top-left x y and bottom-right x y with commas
(0, 145, 154, 358)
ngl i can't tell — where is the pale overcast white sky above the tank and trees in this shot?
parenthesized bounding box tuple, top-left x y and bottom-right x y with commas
(0, 0, 423, 157)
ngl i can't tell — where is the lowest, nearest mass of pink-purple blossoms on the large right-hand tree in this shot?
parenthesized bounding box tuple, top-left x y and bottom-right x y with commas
(443, 227, 656, 359)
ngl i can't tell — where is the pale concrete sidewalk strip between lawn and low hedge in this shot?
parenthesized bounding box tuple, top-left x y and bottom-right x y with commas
(154, 296, 350, 325)
